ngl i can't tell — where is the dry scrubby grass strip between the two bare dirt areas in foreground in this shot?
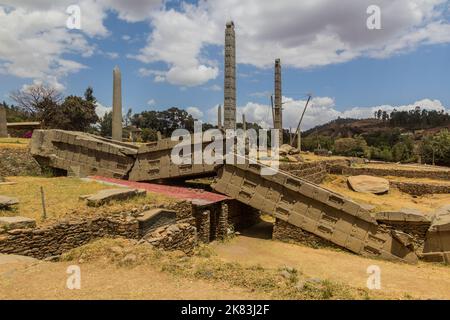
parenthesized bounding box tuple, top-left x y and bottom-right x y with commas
(61, 238, 376, 300)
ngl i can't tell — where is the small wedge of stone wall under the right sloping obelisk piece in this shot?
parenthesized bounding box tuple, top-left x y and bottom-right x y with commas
(272, 218, 338, 248)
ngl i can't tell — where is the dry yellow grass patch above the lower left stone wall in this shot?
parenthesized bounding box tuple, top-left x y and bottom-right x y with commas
(0, 177, 174, 224)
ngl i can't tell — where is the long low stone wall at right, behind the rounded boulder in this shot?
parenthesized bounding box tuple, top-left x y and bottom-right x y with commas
(330, 165, 450, 180)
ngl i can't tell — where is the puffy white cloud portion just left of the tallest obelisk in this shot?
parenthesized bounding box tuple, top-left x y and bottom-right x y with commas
(130, 4, 221, 87)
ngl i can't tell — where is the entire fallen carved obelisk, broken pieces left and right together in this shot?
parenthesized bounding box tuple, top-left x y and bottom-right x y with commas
(31, 130, 430, 262)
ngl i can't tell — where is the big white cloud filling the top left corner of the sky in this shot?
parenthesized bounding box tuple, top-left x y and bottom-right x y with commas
(0, 0, 162, 88)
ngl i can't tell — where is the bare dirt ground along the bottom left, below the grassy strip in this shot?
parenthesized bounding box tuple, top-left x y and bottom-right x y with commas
(0, 259, 267, 300)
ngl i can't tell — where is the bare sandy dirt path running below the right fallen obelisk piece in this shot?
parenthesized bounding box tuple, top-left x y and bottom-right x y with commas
(213, 222, 450, 299)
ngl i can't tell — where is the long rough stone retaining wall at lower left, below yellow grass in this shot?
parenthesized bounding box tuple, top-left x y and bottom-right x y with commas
(0, 217, 139, 259)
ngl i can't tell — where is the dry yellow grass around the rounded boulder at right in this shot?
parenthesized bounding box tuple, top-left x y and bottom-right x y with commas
(321, 175, 450, 213)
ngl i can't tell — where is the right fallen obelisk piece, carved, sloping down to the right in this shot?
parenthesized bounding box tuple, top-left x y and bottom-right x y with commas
(212, 164, 417, 263)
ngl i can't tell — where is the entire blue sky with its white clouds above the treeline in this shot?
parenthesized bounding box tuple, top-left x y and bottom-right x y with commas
(0, 0, 450, 129)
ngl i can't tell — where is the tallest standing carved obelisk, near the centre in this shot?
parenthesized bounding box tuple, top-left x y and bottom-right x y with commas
(223, 21, 236, 130)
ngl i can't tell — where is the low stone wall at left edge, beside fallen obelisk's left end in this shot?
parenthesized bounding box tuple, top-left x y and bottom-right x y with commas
(0, 148, 41, 177)
